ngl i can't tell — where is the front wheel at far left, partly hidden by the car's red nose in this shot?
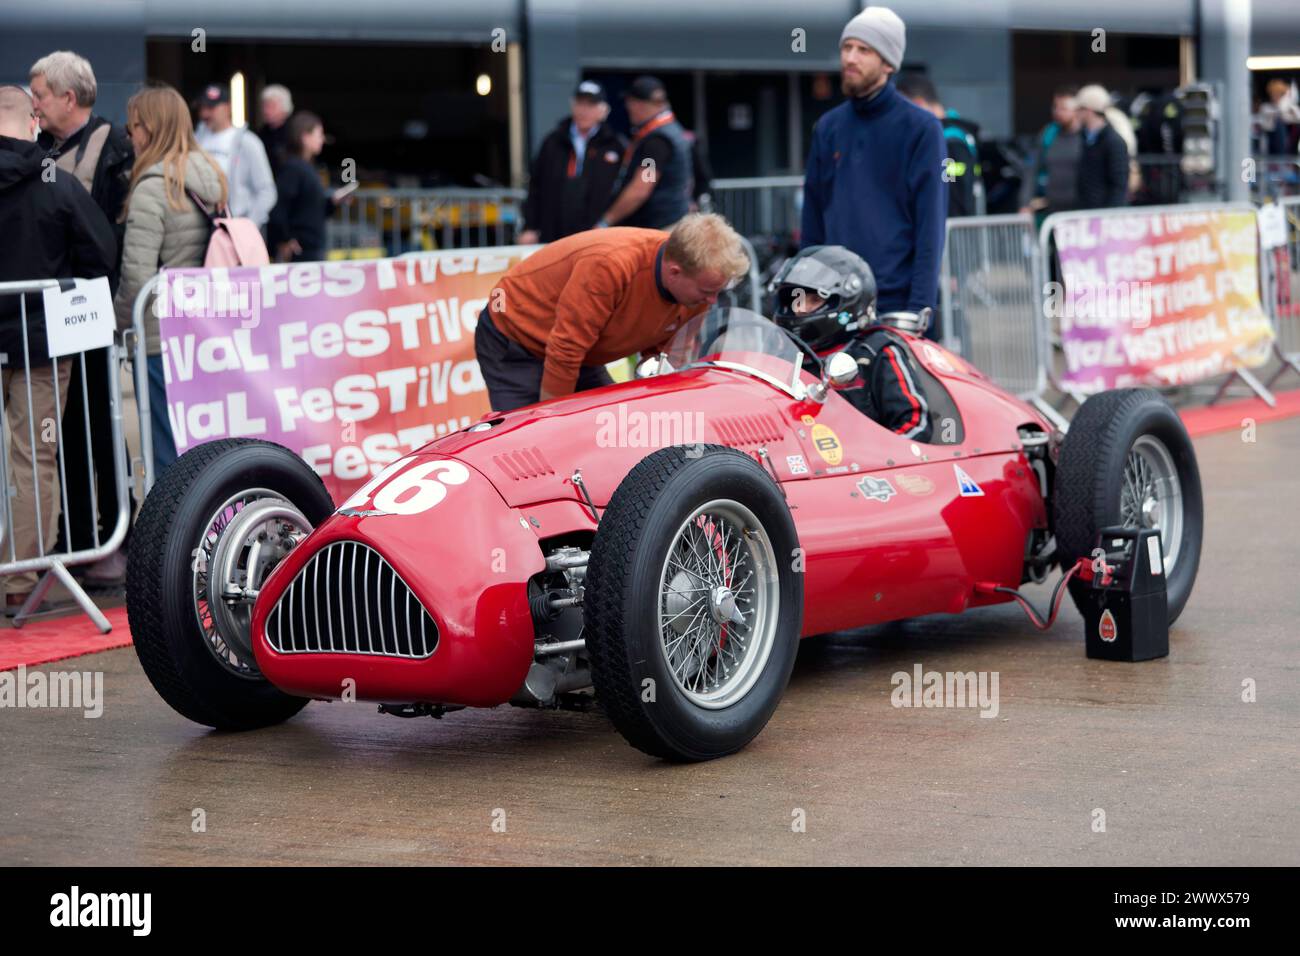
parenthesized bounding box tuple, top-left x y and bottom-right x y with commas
(126, 438, 334, 730)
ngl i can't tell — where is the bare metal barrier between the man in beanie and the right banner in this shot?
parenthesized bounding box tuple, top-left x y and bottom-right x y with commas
(939, 215, 1054, 414)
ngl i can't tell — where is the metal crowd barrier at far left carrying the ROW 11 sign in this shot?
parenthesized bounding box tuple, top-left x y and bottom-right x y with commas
(0, 280, 130, 633)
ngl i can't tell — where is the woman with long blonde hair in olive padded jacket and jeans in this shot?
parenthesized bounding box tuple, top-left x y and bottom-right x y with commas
(114, 86, 228, 477)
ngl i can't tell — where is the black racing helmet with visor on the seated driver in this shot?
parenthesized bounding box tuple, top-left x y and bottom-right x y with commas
(770, 246, 876, 351)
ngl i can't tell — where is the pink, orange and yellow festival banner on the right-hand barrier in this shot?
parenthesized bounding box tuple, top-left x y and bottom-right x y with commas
(1047, 209, 1273, 394)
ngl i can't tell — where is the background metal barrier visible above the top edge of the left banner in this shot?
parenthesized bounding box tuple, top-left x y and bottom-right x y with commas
(326, 189, 528, 258)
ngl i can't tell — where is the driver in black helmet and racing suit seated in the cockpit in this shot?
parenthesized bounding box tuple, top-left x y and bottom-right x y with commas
(772, 246, 931, 442)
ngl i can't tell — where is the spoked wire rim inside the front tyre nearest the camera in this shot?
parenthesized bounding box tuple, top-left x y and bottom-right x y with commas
(659, 499, 780, 708)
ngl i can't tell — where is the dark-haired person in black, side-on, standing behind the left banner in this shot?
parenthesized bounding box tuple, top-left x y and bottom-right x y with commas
(267, 111, 346, 263)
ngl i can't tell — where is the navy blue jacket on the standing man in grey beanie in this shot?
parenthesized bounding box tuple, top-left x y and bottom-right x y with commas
(800, 83, 948, 312)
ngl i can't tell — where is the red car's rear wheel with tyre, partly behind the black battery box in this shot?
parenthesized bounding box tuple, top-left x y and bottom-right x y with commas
(1053, 389, 1204, 624)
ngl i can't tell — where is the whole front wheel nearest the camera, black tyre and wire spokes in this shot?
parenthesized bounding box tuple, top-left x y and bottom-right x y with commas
(584, 445, 803, 761)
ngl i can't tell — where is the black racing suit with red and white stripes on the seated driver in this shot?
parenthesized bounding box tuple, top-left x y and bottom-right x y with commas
(839, 326, 932, 442)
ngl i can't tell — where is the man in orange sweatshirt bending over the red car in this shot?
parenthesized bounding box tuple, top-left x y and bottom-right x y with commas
(475, 215, 749, 411)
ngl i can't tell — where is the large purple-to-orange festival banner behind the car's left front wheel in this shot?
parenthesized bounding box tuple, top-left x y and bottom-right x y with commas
(158, 247, 533, 501)
